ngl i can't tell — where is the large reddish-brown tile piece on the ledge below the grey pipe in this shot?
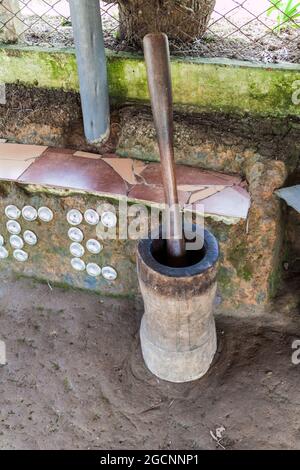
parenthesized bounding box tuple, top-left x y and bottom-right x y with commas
(20, 149, 127, 195)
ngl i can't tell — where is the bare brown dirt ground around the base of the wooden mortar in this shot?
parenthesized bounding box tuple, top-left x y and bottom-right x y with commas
(0, 279, 300, 450)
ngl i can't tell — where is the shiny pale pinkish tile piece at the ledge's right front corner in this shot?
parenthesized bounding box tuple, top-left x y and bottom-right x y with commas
(201, 187, 250, 219)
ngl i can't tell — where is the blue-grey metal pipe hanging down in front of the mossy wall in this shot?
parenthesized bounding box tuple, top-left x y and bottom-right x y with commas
(70, 0, 110, 144)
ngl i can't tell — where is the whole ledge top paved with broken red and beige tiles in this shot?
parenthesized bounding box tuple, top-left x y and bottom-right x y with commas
(0, 143, 250, 218)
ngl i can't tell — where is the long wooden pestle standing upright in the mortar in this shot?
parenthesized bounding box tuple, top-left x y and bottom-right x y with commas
(144, 33, 185, 266)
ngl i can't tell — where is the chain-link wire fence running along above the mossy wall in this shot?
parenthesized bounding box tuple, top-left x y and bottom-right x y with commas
(0, 0, 300, 63)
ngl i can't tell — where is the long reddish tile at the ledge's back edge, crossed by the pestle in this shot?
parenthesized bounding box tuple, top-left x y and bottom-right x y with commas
(141, 163, 241, 186)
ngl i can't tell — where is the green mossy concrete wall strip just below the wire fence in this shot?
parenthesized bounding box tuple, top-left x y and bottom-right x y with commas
(0, 46, 300, 117)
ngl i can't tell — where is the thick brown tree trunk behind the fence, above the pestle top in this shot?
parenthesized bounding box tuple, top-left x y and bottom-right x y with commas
(106, 0, 216, 43)
